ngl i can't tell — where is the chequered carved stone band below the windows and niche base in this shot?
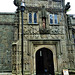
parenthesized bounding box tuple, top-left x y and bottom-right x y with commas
(24, 25, 65, 35)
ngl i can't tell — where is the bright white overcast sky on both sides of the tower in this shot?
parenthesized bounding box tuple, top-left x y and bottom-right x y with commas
(0, 0, 75, 14)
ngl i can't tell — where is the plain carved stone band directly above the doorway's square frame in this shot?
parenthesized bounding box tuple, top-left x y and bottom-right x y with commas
(24, 34, 64, 40)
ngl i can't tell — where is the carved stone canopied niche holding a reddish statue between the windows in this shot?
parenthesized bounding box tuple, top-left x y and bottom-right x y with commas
(39, 6, 50, 34)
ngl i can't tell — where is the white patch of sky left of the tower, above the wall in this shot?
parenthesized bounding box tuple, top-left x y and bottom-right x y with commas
(0, 0, 17, 12)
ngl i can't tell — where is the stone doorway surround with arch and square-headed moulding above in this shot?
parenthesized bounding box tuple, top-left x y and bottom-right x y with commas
(29, 40, 60, 74)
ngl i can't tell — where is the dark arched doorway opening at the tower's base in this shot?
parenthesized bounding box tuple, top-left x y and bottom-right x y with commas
(36, 48, 54, 75)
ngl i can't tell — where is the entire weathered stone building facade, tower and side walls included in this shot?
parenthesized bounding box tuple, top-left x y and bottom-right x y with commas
(0, 0, 75, 75)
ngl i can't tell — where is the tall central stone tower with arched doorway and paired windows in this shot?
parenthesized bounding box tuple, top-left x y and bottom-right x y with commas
(13, 0, 66, 75)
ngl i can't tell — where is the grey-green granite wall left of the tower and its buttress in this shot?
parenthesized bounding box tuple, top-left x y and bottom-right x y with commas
(0, 13, 15, 72)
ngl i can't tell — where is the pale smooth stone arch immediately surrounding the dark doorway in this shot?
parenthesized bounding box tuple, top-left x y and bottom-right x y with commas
(34, 45, 57, 74)
